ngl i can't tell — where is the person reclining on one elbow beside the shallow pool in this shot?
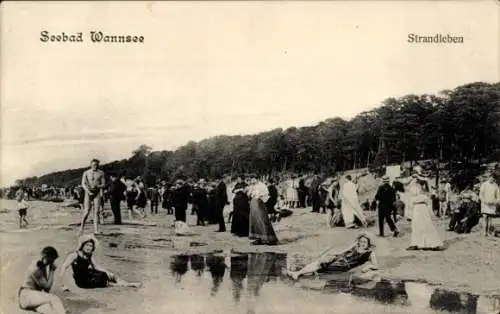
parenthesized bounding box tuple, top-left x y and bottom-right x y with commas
(288, 233, 378, 280)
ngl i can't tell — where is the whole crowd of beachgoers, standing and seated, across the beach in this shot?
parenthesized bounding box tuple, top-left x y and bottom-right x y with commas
(8, 159, 500, 313)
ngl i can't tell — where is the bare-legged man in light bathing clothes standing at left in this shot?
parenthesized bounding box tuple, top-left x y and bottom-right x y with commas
(80, 159, 106, 234)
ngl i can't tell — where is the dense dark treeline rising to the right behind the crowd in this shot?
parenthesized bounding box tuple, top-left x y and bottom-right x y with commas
(15, 82, 500, 189)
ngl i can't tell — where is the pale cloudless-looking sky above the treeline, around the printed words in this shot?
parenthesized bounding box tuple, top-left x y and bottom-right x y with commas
(1, 1, 500, 185)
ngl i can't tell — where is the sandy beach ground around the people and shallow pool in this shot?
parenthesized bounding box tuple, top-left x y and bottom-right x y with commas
(0, 200, 500, 314)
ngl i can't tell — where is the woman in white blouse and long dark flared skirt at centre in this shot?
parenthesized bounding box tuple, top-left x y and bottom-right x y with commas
(249, 180, 278, 245)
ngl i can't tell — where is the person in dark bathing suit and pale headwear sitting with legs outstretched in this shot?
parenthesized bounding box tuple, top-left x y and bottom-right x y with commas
(61, 235, 141, 290)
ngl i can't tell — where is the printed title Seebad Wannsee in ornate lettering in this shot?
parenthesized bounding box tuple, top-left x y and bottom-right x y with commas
(40, 31, 144, 43)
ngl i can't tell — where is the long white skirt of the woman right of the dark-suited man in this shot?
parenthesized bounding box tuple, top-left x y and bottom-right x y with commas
(411, 204, 443, 249)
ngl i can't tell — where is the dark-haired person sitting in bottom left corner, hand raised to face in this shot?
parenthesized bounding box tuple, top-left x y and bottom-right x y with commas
(18, 246, 66, 314)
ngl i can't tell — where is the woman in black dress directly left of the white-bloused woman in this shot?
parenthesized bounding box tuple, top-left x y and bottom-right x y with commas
(231, 178, 250, 237)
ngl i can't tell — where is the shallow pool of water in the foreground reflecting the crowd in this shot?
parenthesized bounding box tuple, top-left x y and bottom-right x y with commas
(168, 253, 500, 314)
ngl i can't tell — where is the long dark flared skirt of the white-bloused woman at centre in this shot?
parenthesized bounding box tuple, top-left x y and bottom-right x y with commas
(249, 198, 278, 244)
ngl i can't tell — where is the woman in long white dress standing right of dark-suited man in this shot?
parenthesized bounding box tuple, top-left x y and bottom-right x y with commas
(407, 180, 443, 250)
